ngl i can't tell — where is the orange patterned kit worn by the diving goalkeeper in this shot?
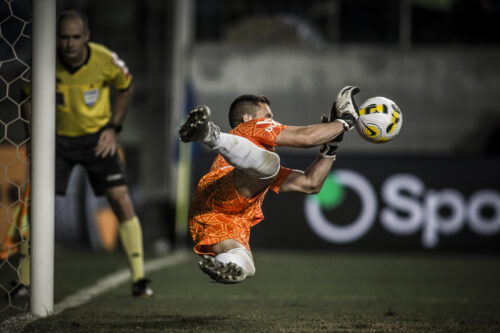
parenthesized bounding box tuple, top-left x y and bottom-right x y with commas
(189, 118, 291, 254)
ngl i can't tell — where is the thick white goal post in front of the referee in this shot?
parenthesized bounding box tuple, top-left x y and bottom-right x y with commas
(30, 0, 57, 316)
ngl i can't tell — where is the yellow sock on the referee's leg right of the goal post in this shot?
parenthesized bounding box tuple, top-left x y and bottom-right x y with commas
(119, 216, 144, 282)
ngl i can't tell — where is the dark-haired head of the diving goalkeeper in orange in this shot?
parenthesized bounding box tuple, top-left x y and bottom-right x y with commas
(229, 95, 273, 128)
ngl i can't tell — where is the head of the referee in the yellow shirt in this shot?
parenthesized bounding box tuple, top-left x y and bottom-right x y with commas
(57, 10, 90, 61)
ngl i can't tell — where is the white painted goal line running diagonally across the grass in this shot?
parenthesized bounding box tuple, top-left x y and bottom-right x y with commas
(0, 251, 189, 333)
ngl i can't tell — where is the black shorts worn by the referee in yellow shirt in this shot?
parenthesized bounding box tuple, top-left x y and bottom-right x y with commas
(56, 130, 127, 195)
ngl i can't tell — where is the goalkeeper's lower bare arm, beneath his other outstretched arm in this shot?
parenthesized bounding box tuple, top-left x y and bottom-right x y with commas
(280, 155, 335, 194)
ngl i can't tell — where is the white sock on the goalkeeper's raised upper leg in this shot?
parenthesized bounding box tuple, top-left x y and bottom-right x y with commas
(213, 133, 280, 179)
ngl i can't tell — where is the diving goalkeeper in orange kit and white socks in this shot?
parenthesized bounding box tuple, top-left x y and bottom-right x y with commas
(179, 86, 359, 283)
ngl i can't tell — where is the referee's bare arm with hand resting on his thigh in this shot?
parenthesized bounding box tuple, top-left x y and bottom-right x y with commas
(95, 84, 133, 157)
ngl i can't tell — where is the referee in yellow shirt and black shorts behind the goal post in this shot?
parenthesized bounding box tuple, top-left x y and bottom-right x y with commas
(20, 10, 153, 297)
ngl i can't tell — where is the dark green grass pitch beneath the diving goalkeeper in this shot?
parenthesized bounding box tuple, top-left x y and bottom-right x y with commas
(0, 249, 500, 332)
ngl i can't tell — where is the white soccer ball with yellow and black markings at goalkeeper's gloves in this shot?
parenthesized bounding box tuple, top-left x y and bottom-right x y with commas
(356, 96, 403, 143)
